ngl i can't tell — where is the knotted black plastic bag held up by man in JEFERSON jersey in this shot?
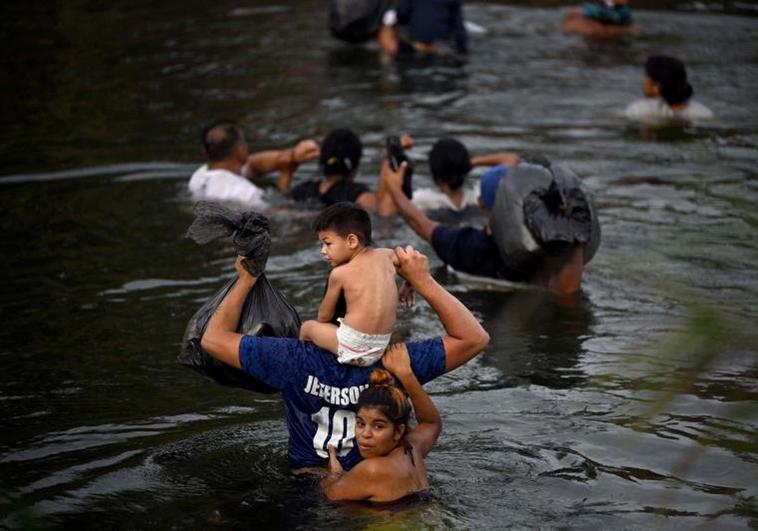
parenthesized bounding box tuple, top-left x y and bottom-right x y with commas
(177, 202, 300, 393)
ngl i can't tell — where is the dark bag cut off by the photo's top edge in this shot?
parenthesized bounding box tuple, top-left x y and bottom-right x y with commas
(329, 0, 389, 44)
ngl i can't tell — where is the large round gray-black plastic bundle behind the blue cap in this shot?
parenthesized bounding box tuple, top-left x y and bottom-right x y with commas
(492, 163, 600, 271)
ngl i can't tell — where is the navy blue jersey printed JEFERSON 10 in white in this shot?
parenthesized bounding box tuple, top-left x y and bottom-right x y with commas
(239, 336, 445, 470)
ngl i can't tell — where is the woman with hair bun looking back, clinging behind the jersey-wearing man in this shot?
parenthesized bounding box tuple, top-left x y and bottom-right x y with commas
(321, 345, 442, 502)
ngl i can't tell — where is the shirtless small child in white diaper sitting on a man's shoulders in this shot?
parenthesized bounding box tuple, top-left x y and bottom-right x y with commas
(300, 202, 398, 366)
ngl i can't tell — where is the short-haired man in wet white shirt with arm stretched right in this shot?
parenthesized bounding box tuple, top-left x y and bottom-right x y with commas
(189, 120, 319, 206)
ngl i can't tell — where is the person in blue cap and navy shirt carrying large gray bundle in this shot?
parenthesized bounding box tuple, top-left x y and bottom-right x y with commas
(381, 157, 600, 294)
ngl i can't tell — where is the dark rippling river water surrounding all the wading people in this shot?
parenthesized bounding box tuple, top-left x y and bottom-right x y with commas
(0, 0, 758, 529)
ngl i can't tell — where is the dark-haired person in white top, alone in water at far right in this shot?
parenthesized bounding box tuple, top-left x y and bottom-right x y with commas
(624, 55, 713, 121)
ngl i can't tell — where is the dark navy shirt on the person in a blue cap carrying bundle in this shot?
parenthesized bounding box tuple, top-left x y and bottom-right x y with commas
(432, 225, 529, 282)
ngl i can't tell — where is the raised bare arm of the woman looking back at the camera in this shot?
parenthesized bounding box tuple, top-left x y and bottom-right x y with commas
(382, 344, 442, 457)
